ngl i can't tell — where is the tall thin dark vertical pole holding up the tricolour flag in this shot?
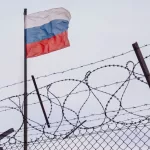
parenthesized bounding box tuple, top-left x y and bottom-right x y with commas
(24, 8, 28, 150)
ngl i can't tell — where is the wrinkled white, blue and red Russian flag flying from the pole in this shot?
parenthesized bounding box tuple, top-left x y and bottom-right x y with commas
(25, 8, 71, 58)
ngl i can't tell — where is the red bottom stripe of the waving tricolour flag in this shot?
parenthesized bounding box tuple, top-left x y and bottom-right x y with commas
(27, 31, 70, 58)
